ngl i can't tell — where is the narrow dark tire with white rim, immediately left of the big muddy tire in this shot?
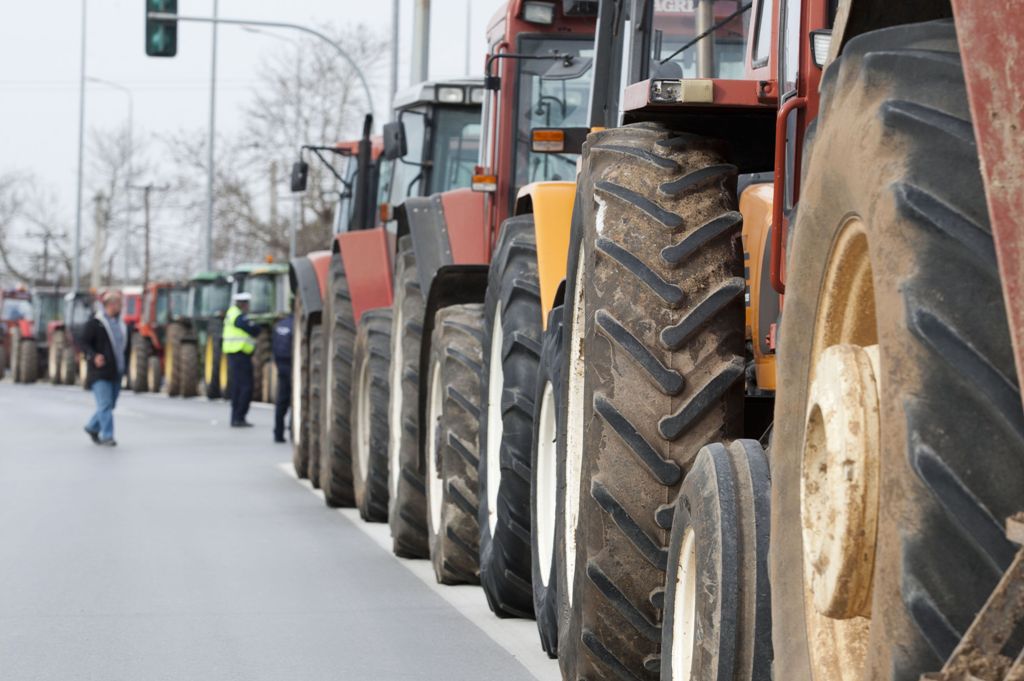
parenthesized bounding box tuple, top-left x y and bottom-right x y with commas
(529, 305, 567, 657)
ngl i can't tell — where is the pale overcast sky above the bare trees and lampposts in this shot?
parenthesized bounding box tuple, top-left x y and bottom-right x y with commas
(0, 0, 503, 233)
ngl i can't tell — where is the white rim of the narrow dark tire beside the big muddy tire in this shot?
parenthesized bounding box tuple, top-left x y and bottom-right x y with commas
(534, 381, 558, 587)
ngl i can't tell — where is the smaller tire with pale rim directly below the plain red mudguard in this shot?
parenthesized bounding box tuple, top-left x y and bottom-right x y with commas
(349, 307, 391, 522)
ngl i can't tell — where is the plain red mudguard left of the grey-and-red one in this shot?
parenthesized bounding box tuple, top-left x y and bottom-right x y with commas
(332, 227, 394, 325)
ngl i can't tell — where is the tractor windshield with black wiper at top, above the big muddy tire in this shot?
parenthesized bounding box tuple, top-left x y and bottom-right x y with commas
(650, 0, 750, 80)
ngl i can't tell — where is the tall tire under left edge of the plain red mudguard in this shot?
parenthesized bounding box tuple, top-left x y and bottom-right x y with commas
(319, 255, 355, 506)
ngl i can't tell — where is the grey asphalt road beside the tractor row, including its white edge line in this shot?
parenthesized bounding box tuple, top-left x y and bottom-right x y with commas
(0, 379, 558, 681)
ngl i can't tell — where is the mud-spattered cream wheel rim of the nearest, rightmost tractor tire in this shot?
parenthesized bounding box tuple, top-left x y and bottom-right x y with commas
(800, 218, 881, 681)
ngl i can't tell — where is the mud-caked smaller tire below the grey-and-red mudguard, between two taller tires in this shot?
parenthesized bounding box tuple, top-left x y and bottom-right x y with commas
(423, 304, 483, 584)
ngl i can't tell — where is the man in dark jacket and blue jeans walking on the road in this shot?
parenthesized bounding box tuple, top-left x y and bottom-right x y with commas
(82, 291, 128, 446)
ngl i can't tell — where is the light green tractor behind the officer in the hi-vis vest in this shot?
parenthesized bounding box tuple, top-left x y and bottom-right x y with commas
(225, 263, 292, 402)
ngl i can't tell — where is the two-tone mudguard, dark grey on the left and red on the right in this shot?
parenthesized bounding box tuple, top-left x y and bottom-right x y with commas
(397, 189, 490, 295)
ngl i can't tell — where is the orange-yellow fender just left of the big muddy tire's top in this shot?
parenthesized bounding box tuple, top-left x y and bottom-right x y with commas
(516, 182, 575, 328)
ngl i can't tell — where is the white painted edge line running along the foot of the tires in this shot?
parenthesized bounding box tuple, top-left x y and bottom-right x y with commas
(278, 462, 562, 681)
